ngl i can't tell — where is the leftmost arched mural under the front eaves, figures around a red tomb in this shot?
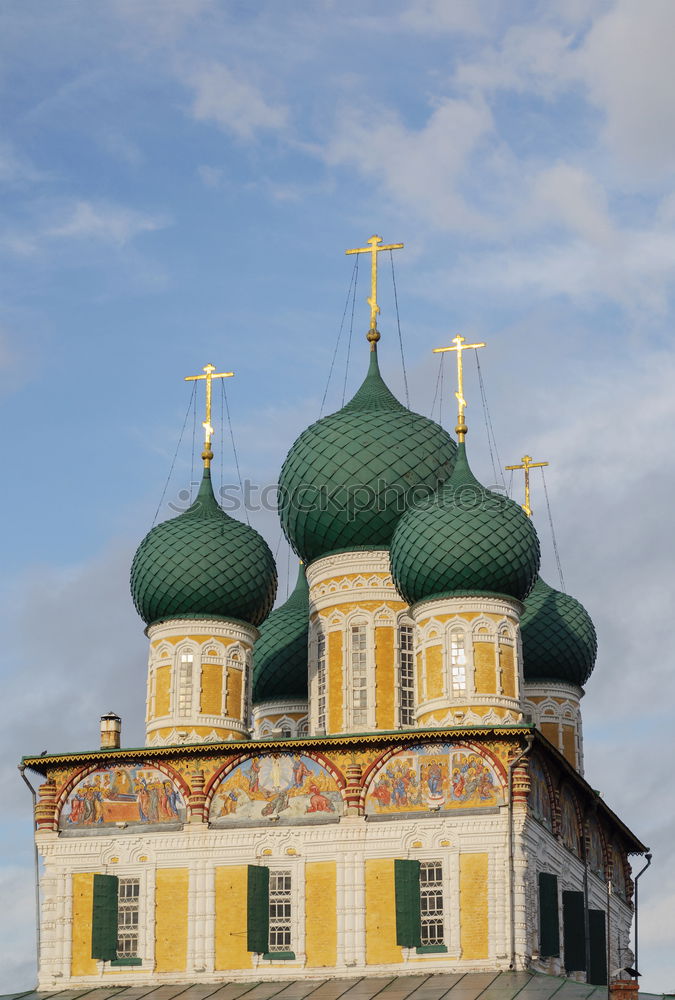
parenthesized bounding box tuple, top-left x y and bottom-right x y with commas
(59, 764, 186, 831)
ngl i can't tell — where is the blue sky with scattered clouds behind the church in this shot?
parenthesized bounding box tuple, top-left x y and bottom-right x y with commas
(0, 0, 675, 991)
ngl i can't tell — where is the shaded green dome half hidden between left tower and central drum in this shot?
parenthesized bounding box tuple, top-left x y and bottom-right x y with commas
(253, 564, 309, 705)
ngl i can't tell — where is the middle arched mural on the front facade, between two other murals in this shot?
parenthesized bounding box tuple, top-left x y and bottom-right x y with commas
(209, 754, 342, 826)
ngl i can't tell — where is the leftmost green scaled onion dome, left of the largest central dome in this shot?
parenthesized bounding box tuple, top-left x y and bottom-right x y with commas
(131, 469, 277, 625)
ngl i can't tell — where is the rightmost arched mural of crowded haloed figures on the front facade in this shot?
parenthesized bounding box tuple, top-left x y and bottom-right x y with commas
(366, 743, 504, 816)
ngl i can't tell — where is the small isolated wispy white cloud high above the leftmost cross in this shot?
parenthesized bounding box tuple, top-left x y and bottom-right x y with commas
(185, 62, 288, 140)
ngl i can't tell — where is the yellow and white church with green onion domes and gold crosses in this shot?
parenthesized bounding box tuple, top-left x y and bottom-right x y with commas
(22, 237, 647, 996)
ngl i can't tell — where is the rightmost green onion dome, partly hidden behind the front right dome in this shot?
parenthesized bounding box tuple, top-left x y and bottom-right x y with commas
(520, 577, 598, 687)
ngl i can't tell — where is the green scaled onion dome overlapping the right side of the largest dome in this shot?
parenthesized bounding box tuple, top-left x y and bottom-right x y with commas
(391, 442, 539, 604)
